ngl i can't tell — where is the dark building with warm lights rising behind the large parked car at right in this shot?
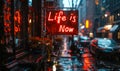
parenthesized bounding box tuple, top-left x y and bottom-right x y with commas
(94, 0, 120, 42)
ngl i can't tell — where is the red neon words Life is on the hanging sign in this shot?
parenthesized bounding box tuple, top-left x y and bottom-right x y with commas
(48, 11, 77, 23)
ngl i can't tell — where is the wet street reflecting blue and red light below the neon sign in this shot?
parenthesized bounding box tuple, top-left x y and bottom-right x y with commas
(48, 38, 120, 71)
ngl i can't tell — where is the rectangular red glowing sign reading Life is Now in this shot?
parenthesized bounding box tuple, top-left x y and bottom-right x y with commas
(46, 10, 78, 35)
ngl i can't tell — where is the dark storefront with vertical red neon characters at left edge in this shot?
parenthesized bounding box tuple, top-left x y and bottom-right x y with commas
(0, 0, 28, 68)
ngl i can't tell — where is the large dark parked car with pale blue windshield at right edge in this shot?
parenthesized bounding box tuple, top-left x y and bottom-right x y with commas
(90, 38, 120, 60)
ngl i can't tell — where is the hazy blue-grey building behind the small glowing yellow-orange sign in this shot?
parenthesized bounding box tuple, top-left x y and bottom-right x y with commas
(79, 0, 95, 36)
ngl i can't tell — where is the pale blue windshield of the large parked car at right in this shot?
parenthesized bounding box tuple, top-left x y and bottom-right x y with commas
(98, 39, 117, 47)
